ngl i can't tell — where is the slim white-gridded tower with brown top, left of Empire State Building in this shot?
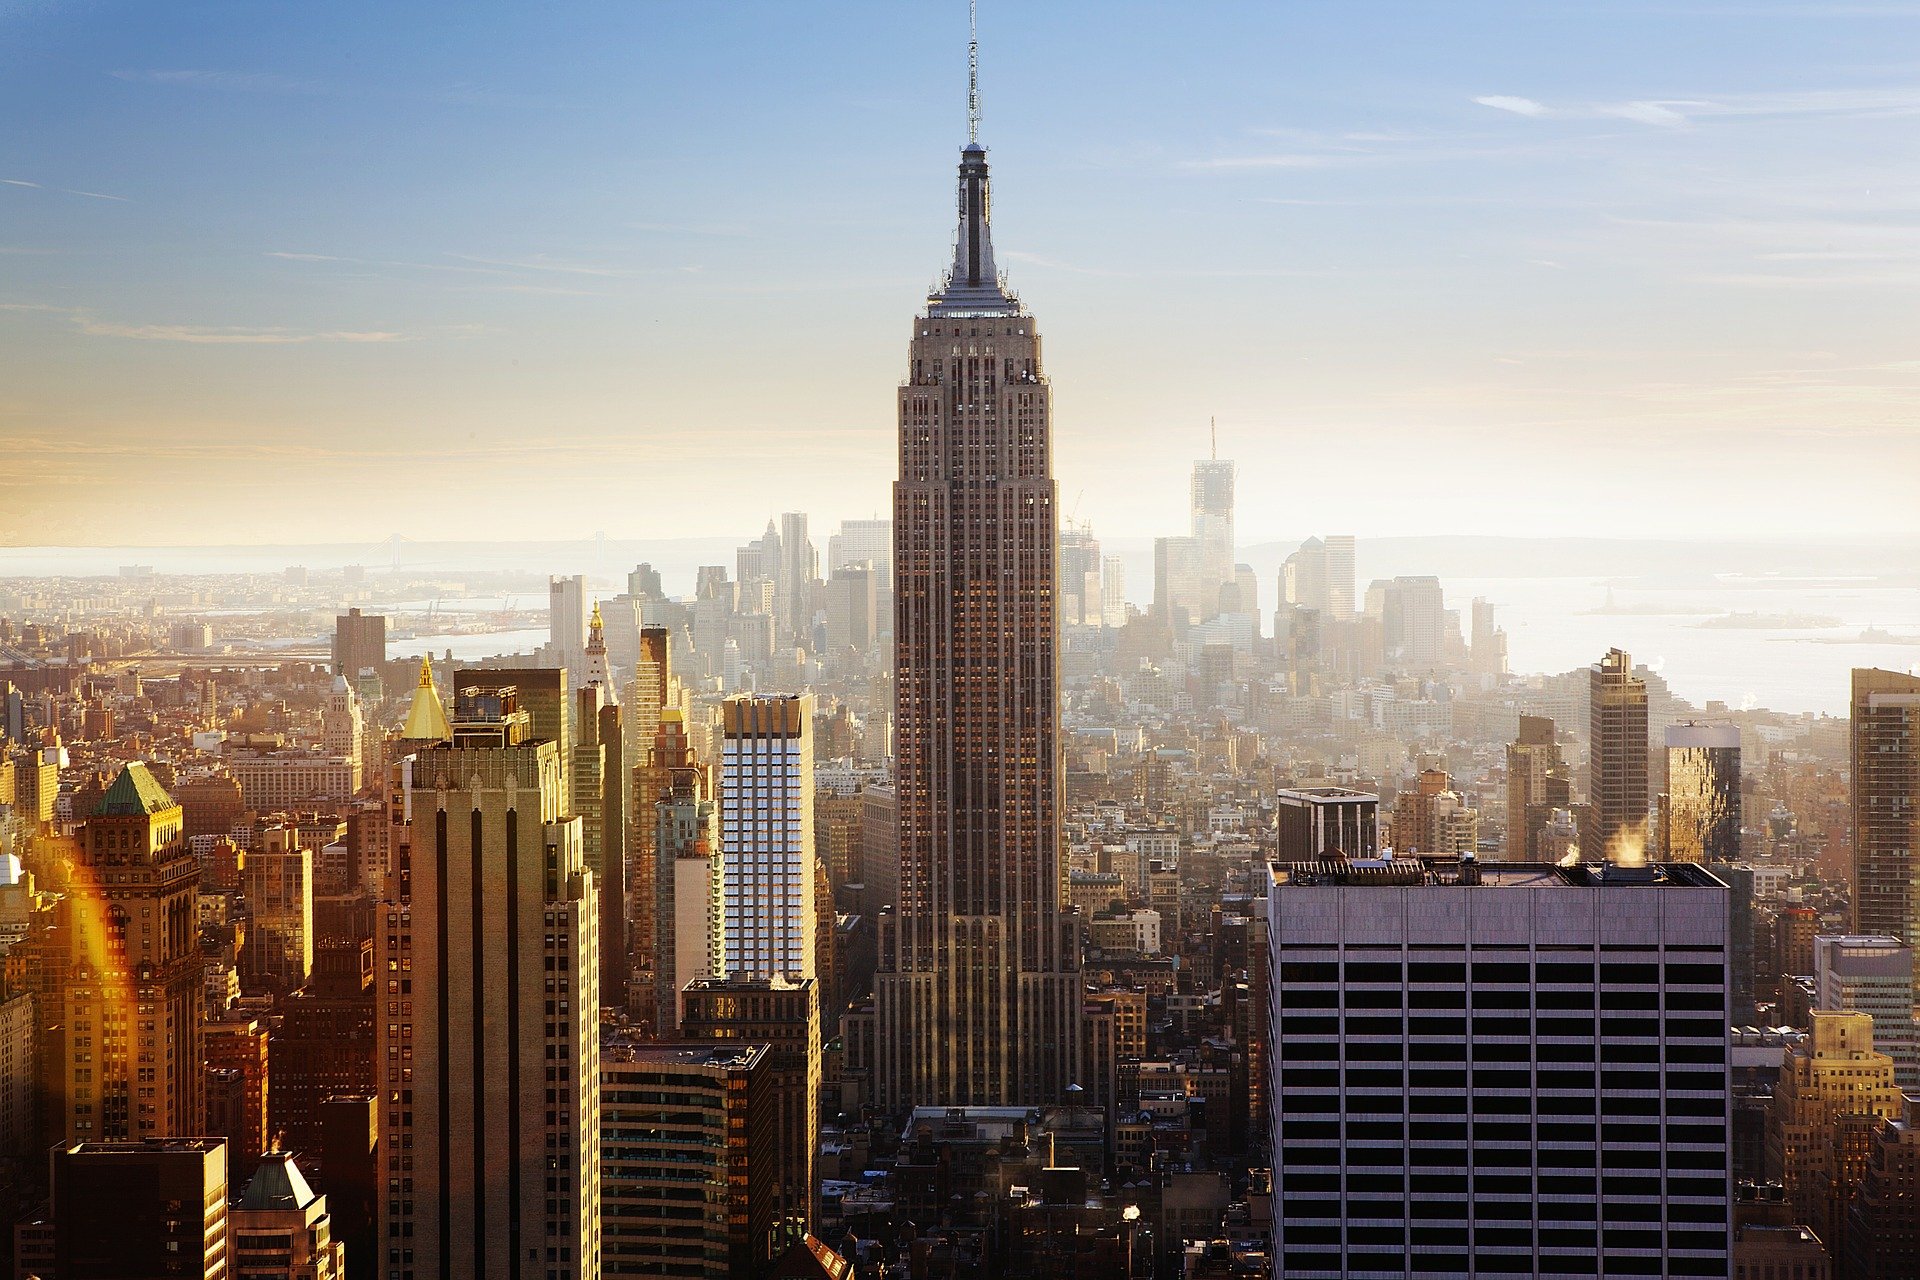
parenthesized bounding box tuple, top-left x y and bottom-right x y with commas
(720, 695, 826, 979)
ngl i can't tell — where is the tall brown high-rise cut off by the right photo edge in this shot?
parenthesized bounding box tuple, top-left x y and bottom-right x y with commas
(1851, 668, 1920, 946)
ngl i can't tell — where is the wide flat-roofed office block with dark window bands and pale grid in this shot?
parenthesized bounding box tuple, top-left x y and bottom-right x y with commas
(1267, 858, 1730, 1278)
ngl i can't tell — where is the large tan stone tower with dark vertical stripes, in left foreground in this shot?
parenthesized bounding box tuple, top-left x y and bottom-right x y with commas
(374, 687, 601, 1280)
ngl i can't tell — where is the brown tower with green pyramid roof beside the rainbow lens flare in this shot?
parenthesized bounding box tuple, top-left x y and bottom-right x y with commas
(60, 764, 204, 1143)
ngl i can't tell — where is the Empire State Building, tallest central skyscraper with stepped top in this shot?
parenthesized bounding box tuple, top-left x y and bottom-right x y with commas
(874, 130, 1081, 1109)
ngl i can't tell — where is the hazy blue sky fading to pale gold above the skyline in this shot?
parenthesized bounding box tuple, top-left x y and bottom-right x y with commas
(0, 0, 1920, 545)
